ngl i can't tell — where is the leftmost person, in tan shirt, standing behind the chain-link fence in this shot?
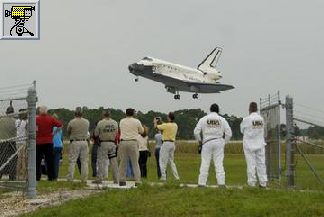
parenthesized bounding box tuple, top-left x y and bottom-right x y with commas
(0, 105, 17, 181)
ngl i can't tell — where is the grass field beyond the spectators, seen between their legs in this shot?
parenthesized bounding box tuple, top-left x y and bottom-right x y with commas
(55, 142, 324, 190)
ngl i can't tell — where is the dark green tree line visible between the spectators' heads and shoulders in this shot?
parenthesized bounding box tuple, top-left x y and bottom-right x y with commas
(49, 107, 242, 140)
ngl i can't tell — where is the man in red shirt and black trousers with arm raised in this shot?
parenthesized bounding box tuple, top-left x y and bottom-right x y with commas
(36, 106, 62, 181)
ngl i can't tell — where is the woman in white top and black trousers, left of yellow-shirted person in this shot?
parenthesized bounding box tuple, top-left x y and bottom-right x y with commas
(137, 126, 149, 178)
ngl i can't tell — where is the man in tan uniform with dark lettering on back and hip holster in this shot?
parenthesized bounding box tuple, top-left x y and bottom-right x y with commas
(94, 110, 118, 184)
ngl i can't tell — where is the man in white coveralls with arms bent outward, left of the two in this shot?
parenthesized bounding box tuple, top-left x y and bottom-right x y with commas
(194, 103, 232, 188)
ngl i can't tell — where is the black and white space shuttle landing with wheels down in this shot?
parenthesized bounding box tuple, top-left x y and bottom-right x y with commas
(128, 47, 234, 100)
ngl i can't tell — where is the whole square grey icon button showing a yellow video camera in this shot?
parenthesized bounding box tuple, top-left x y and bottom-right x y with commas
(0, 0, 39, 40)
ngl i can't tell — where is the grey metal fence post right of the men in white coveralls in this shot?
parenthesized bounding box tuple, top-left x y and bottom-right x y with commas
(285, 96, 295, 188)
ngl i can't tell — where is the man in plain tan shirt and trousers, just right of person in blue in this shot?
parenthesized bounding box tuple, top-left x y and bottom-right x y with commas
(67, 107, 90, 182)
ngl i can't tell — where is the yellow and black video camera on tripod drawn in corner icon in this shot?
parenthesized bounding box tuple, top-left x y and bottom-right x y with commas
(5, 6, 35, 36)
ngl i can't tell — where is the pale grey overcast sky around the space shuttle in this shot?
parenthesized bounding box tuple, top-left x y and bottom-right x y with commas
(0, 0, 324, 119)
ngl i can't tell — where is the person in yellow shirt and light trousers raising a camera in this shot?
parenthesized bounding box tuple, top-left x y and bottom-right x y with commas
(153, 112, 180, 181)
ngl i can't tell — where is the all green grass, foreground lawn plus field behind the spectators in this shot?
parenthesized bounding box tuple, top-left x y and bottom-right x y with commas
(14, 144, 324, 217)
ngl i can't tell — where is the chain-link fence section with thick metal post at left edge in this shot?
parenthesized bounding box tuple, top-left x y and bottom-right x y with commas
(0, 82, 36, 197)
